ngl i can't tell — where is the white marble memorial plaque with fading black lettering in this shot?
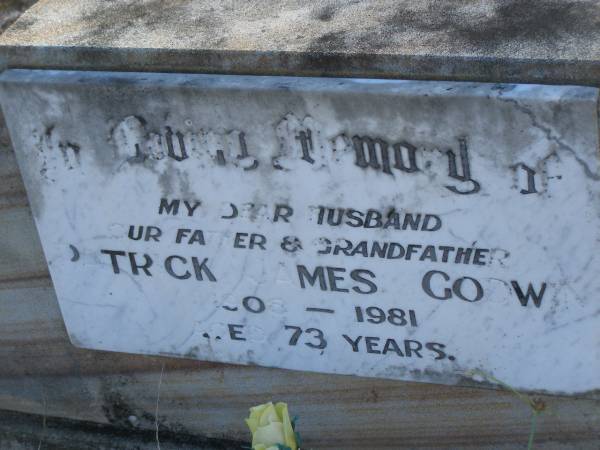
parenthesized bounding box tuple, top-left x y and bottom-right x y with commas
(1, 70, 600, 394)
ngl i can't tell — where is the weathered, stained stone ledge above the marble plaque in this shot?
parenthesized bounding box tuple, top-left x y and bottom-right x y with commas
(0, 0, 600, 86)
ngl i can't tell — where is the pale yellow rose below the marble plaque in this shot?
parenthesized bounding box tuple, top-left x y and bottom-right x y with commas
(246, 402, 298, 450)
